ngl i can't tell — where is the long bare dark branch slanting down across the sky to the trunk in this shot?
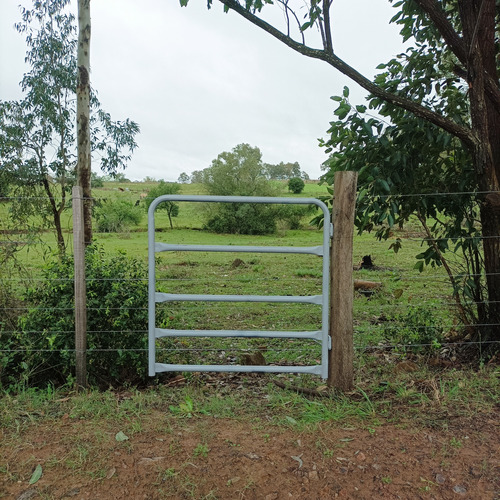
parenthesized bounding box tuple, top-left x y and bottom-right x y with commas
(219, 0, 477, 148)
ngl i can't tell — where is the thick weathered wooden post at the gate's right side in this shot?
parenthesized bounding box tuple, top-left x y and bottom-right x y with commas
(327, 172, 358, 391)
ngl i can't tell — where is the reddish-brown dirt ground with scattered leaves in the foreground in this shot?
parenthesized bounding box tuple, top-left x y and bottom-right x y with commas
(0, 402, 500, 500)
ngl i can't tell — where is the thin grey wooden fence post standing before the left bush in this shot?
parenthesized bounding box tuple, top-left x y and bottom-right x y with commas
(72, 186, 87, 390)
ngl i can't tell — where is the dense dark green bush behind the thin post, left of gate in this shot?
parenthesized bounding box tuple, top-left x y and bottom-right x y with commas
(8, 247, 168, 387)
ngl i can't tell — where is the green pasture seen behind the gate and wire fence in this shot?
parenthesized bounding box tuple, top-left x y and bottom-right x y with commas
(2, 182, 453, 372)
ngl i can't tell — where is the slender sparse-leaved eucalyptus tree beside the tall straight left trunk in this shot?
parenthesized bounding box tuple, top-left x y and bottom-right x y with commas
(0, 0, 139, 253)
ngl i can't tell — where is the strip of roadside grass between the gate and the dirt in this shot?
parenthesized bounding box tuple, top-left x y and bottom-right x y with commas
(0, 363, 500, 434)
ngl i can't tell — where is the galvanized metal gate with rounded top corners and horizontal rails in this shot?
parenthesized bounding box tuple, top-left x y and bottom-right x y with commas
(148, 195, 333, 379)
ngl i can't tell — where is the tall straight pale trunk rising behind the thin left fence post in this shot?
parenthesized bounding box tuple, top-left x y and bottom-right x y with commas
(76, 0, 92, 245)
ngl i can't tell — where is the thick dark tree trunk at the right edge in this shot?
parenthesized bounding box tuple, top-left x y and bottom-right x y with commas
(459, 0, 500, 341)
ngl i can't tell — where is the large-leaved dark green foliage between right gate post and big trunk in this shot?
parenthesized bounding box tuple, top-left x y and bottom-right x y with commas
(321, 60, 487, 332)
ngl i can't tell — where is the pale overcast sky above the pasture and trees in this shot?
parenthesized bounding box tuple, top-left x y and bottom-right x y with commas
(0, 0, 402, 181)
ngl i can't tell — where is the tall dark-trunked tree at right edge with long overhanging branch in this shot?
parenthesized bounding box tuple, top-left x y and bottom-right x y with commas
(188, 0, 500, 340)
